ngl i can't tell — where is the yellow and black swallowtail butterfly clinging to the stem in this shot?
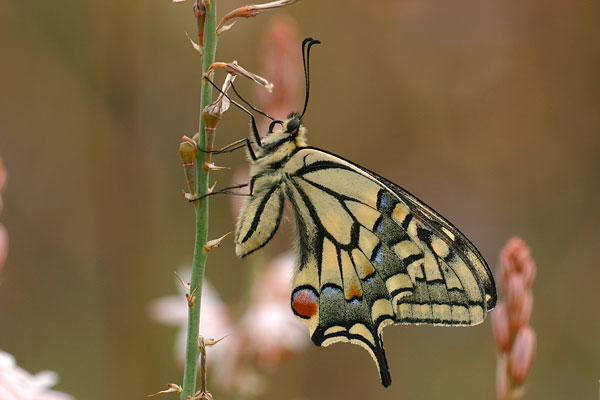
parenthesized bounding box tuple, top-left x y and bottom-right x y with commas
(227, 38, 496, 387)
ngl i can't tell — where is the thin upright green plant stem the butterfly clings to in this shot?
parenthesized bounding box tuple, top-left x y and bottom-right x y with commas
(181, 0, 217, 400)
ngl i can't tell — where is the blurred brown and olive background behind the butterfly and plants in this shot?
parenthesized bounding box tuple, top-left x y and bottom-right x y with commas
(0, 0, 600, 400)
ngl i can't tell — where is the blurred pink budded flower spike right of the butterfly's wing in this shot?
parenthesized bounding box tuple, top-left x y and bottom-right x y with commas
(492, 238, 537, 400)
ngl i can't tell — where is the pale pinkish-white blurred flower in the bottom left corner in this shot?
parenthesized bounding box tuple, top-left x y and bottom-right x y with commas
(0, 350, 73, 400)
